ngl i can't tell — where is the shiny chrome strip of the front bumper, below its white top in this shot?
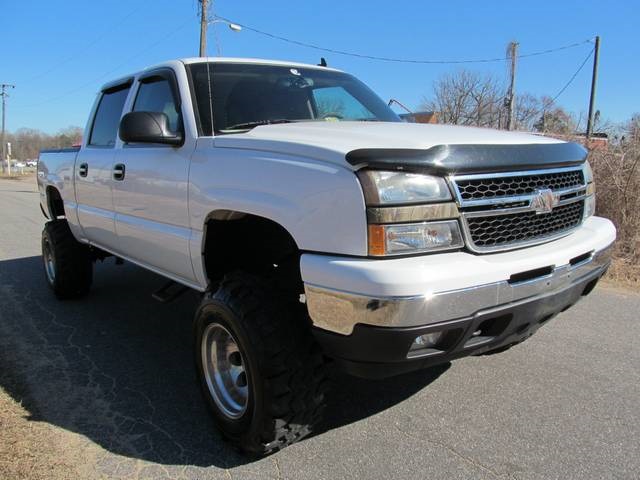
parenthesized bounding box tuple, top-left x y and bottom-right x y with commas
(305, 244, 613, 335)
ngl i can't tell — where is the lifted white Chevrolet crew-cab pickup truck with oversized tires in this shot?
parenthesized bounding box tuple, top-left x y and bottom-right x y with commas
(38, 59, 615, 453)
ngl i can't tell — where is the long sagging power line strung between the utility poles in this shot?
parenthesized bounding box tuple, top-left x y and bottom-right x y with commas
(215, 15, 592, 65)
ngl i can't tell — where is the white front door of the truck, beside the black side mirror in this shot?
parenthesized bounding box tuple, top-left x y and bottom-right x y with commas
(113, 68, 195, 283)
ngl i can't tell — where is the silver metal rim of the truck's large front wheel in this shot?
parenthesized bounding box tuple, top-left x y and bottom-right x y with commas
(200, 323, 249, 419)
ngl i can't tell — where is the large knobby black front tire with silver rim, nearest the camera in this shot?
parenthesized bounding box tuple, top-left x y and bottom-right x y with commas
(194, 273, 327, 455)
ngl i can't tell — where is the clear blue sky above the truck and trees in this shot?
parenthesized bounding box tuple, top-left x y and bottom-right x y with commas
(0, 0, 640, 132)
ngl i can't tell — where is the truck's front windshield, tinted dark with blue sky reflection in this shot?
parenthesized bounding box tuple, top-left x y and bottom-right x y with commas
(188, 62, 400, 135)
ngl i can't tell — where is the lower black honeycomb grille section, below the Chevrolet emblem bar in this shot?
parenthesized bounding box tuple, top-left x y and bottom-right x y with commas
(466, 200, 584, 249)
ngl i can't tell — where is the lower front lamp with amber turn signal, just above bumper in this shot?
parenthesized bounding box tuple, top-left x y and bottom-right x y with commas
(369, 220, 463, 256)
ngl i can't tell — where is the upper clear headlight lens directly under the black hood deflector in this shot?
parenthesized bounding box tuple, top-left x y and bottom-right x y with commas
(358, 170, 451, 206)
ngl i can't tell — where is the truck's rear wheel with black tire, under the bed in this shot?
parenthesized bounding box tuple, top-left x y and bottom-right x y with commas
(42, 219, 93, 299)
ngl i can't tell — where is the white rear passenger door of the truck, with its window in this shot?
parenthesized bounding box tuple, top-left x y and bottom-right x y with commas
(74, 79, 133, 250)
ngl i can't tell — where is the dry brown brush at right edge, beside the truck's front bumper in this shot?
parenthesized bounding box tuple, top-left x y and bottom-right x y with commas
(589, 139, 640, 288)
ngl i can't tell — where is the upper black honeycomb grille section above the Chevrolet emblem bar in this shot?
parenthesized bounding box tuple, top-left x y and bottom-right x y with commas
(456, 170, 584, 201)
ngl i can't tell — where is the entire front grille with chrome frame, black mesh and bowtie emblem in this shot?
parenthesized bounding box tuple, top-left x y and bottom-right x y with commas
(449, 166, 587, 253)
